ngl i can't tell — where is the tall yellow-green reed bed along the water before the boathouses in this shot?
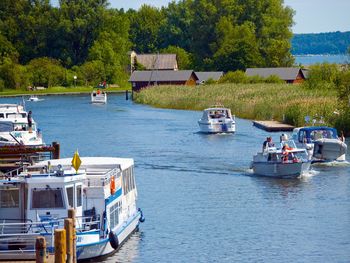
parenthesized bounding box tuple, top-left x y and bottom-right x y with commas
(134, 84, 337, 126)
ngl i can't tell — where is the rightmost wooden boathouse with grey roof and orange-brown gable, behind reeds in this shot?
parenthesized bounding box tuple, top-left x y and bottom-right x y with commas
(246, 67, 306, 84)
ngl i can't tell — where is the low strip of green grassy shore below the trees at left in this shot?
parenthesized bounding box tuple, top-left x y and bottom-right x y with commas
(0, 86, 131, 97)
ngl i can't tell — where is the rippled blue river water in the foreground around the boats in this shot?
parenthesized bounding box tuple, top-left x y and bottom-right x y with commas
(0, 95, 350, 263)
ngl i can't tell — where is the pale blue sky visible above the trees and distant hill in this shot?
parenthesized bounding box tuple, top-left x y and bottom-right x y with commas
(109, 0, 350, 34)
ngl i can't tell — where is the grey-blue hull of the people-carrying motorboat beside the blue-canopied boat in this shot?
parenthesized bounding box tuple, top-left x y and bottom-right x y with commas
(252, 162, 311, 178)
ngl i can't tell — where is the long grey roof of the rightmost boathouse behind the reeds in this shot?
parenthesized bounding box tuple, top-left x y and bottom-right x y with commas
(245, 68, 305, 80)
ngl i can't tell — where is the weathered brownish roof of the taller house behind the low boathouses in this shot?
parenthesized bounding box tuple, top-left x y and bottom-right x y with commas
(136, 54, 178, 70)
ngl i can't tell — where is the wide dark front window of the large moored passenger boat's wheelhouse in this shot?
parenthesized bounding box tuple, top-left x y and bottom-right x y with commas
(32, 188, 64, 209)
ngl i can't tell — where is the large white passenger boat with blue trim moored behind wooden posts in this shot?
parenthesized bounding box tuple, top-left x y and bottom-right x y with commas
(0, 157, 144, 261)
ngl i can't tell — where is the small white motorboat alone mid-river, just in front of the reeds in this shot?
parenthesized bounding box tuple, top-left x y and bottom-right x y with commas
(198, 106, 236, 133)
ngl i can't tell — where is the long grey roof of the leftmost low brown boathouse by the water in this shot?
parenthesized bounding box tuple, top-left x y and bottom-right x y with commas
(129, 70, 198, 82)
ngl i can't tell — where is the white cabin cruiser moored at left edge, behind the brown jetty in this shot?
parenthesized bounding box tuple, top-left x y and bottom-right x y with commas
(0, 104, 44, 146)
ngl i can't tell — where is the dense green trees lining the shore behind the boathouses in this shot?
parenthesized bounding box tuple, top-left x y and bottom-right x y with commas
(0, 0, 294, 89)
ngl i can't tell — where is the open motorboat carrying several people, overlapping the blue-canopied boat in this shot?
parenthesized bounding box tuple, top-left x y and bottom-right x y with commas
(251, 140, 311, 178)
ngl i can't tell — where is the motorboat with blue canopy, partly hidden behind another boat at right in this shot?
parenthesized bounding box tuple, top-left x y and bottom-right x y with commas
(292, 126, 347, 162)
